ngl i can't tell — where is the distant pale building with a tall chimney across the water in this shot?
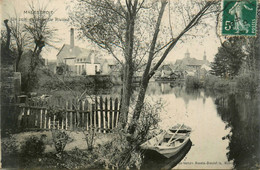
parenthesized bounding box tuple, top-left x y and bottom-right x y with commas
(57, 28, 116, 75)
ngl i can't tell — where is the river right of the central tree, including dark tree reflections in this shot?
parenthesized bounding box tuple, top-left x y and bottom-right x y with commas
(141, 82, 260, 169)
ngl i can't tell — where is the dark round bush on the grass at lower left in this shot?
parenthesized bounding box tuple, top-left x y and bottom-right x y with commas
(21, 136, 46, 157)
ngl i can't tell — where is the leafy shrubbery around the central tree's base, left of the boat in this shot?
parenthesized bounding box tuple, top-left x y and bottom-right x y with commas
(98, 100, 163, 169)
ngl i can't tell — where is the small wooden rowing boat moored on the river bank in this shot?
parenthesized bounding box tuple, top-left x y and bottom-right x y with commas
(140, 124, 191, 158)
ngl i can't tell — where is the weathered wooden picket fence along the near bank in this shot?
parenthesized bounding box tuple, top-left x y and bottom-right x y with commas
(18, 96, 120, 133)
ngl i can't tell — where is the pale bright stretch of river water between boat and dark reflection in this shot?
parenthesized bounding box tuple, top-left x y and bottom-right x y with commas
(147, 83, 233, 169)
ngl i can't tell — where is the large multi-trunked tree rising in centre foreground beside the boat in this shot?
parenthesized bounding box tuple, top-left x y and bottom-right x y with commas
(70, 0, 217, 134)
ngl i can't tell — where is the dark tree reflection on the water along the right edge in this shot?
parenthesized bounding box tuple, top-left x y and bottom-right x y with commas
(215, 94, 260, 169)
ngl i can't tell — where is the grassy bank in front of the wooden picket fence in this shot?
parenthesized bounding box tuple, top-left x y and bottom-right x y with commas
(1, 131, 113, 169)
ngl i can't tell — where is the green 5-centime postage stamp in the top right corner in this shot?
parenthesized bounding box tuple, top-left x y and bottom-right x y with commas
(222, 0, 257, 36)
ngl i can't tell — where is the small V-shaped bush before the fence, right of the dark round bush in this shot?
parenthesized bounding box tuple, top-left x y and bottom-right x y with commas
(51, 129, 70, 155)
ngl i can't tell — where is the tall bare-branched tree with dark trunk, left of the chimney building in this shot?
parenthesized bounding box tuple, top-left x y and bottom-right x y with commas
(20, 2, 56, 92)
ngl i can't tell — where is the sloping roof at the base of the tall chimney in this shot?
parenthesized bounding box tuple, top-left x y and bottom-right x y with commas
(57, 44, 85, 59)
